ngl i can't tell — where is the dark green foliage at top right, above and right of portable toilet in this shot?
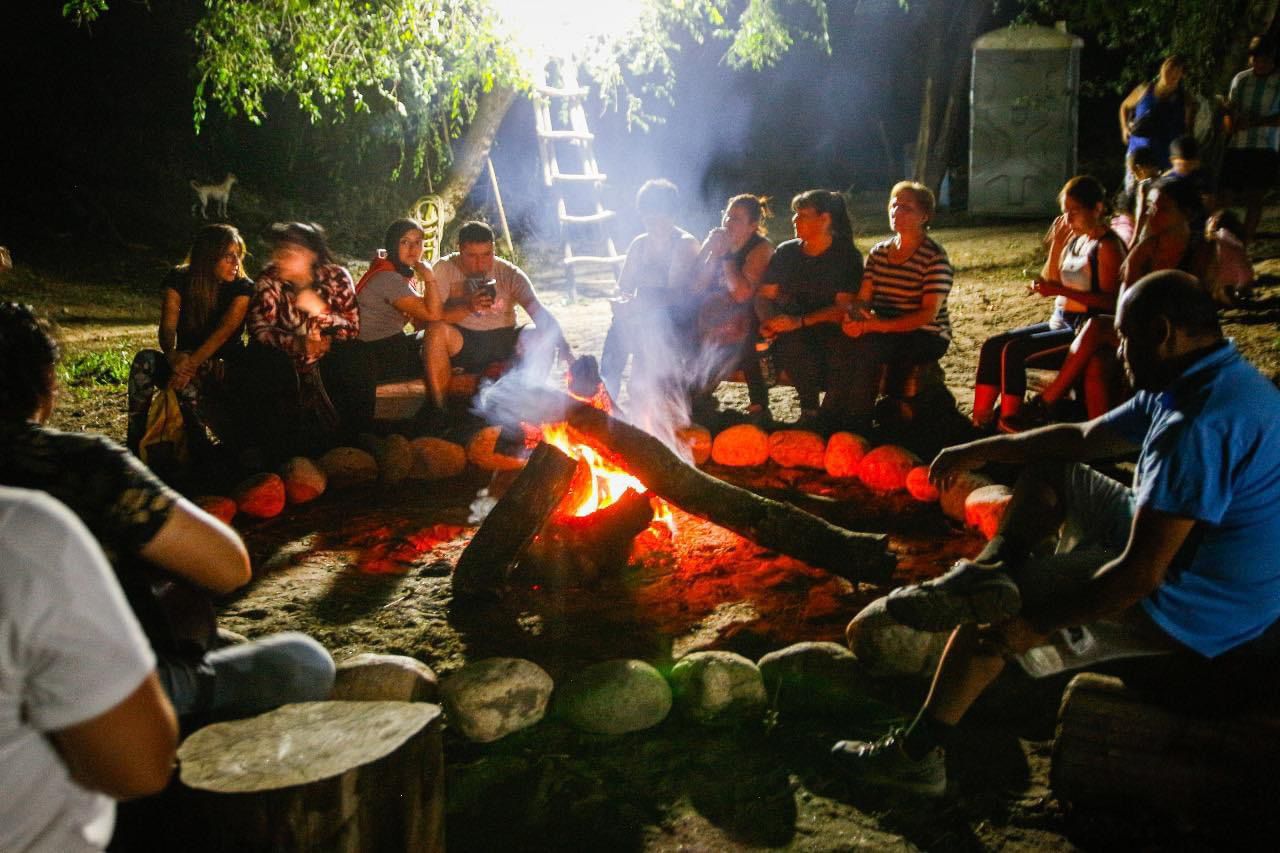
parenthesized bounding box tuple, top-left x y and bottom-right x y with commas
(1015, 0, 1252, 92)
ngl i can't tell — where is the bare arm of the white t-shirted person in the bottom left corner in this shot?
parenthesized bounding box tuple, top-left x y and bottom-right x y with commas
(50, 670, 178, 799)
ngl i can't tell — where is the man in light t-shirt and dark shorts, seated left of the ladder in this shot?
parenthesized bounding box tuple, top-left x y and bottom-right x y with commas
(425, 222, 573, 409)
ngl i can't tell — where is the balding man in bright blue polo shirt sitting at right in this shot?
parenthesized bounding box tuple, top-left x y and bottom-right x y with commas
(832, 270, 1280, 795)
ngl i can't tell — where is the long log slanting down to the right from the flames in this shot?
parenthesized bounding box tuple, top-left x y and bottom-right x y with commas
(504, 391, 896, 583)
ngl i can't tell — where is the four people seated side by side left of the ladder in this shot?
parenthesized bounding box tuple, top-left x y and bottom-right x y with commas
(128, 219, 572, 464)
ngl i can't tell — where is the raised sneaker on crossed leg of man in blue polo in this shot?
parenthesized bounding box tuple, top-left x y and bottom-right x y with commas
(884, 560, 1023, 631)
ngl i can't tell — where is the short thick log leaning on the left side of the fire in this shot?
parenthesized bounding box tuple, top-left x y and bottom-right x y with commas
(453, 443, 577, 597)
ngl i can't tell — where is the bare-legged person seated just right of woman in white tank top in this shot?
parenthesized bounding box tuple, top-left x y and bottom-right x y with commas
(1001, 175, 1206, 432)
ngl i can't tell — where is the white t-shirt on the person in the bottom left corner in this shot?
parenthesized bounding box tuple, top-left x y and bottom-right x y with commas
(0, 487, 155, 853)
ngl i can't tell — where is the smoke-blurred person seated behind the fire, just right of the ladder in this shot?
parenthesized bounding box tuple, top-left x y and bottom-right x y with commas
(600, 178, 699, 406)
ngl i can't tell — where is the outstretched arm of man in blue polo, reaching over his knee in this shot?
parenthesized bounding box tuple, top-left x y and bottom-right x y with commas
(929, 418, 1138, 487)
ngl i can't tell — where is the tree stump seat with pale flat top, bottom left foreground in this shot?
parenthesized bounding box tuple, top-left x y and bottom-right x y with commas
(174, 702, 444, 853)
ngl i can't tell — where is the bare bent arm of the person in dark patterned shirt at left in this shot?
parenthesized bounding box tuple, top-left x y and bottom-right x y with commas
(138, 498, 252, 593)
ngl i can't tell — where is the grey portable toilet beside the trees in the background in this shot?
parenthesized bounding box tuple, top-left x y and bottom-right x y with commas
(969, 24, 1084, 216)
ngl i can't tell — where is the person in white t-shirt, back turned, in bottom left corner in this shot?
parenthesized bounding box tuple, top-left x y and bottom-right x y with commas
(0, 487, 178, 850)
